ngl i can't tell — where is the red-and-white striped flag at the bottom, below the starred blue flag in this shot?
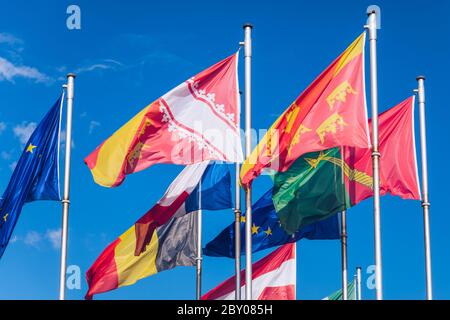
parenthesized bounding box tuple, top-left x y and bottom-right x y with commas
(202, 243, 297, 300)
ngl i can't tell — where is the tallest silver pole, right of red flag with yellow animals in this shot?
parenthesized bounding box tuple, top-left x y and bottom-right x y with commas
(367, 10, 383, 300)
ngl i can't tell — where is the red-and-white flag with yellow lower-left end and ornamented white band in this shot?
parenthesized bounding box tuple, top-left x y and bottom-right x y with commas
(85, 53, 242, 187)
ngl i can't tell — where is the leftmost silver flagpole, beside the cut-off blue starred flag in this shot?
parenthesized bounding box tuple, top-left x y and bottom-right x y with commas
(59, 73, 75, 300)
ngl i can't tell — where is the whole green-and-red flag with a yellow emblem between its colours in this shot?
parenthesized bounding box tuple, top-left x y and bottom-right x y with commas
(273, 97, 420, 234)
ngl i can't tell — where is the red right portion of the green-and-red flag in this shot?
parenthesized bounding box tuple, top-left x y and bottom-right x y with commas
(344, 96, 420, 203)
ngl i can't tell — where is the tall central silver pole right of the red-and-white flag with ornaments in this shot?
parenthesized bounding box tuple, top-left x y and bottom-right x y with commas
(244, 23, 253, 300)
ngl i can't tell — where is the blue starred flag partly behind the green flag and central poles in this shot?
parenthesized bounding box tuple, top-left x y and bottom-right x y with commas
(203, 189, 340, 258)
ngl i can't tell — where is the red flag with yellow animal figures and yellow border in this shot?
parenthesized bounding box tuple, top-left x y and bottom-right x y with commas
(241, 33, 370, 186)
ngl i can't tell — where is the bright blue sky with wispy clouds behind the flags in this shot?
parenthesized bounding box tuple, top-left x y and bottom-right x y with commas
(0, 0, 450, 299)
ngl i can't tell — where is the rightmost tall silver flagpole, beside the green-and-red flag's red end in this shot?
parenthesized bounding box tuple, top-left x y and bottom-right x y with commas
(417, 76, 433, 300)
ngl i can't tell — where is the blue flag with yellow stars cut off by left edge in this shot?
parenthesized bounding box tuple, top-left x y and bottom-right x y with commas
(0, 96, 63, 257)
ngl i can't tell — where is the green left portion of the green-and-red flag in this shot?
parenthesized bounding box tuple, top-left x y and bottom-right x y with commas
(272, 148, 351, 234)
